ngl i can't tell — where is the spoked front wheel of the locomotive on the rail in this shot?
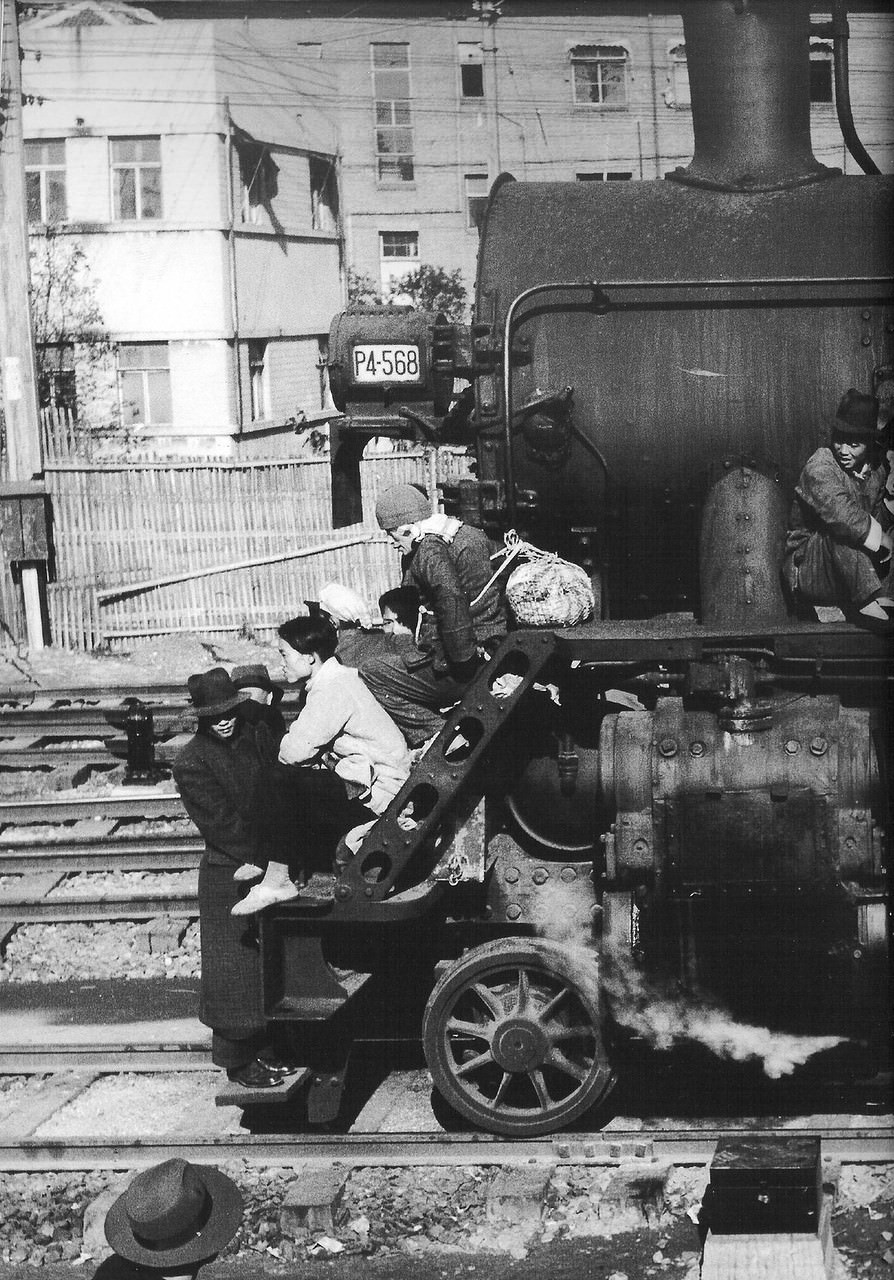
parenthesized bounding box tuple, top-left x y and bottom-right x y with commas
(423, 938, 614, 1138)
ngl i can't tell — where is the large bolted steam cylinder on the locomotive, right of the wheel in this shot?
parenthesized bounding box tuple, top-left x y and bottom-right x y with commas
(599, 696, 882, 892)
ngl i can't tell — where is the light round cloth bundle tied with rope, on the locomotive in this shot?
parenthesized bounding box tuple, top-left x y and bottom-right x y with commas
(471, 529, 596, 627)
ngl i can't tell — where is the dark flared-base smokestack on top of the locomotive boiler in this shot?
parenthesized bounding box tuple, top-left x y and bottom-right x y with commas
(669, 0, 839, 191)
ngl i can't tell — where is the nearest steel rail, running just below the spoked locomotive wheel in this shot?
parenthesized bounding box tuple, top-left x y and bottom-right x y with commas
(0, 1121, 894, 1172)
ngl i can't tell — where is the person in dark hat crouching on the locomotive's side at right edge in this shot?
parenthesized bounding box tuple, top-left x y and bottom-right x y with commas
(783, 388, 894, 631)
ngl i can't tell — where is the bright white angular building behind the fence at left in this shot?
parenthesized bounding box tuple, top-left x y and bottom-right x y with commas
(20, 0, 342, 447)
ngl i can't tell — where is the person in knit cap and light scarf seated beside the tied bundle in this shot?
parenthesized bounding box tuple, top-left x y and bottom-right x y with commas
(360, 484, 506, 746)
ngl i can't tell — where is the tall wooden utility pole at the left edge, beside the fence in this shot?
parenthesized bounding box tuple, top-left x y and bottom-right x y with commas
(0, 0, 47, 649)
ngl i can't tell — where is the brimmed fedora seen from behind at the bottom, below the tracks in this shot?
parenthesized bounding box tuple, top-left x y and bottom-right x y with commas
(105, 1158, 242, 1268)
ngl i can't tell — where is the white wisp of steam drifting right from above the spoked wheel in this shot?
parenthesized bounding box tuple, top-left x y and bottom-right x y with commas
(525, 883, 847, 1080)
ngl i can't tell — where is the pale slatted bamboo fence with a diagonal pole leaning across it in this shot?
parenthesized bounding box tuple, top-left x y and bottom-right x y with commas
(46, 449, 469, 649)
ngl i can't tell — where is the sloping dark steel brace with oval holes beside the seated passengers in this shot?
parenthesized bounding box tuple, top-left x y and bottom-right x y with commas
(330, 631, 556, 920)
